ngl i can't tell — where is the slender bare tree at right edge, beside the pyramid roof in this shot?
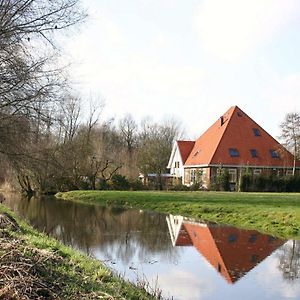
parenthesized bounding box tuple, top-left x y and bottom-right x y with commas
(280, 112, 300, 175)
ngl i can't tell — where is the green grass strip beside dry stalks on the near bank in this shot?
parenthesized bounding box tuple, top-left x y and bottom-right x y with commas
(0, 204, 154, 300)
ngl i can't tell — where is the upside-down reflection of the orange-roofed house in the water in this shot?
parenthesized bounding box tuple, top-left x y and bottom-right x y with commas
(167, 215, 285, 284)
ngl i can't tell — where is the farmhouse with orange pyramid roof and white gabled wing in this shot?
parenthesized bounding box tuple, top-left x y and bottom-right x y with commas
(167, 106, 300, 190)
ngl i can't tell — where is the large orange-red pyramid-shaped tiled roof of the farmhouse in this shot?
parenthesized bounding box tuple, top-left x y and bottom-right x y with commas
(185, 106, 293, 167)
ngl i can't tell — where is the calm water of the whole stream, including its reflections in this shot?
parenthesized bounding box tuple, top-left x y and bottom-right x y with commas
(2, 195, 300, 300)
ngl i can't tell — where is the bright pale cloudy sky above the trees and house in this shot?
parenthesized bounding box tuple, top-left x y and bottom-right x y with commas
(64, 0, 300, 139)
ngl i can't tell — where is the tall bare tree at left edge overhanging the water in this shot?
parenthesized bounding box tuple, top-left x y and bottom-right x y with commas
(0, 0, 86, 191)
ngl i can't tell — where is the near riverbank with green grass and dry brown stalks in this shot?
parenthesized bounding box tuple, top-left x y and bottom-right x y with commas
(0, 204, 154, 300)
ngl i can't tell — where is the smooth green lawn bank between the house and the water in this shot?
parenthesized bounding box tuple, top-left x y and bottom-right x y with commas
(57, 191, 300, 239)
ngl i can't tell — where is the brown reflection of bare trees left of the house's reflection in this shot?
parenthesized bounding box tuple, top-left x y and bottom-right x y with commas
(7, 195, 180, 264)
